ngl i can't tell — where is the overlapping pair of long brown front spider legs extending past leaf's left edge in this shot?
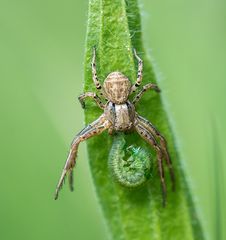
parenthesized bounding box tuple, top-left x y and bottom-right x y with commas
(55, 114, 110, 199)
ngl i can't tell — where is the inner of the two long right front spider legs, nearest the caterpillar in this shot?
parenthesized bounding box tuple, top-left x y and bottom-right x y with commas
(135, 123, 166, 207)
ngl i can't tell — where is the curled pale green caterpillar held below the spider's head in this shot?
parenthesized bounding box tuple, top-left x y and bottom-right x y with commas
(109, 133, 152, 188)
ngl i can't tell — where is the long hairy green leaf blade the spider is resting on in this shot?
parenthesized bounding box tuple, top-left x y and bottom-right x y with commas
(84, 0, 204, 240)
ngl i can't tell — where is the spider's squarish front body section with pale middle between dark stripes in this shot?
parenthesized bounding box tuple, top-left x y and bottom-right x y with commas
(105, 101, 135, 131)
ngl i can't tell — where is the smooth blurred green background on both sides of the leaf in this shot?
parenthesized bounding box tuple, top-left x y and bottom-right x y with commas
(0, 0, 226, 240)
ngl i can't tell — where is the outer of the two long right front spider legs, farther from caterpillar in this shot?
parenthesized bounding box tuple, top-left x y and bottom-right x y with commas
(137, 115, 175, 191)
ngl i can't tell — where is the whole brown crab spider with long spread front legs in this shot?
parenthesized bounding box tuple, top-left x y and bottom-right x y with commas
(55, 48, 175, 205)
